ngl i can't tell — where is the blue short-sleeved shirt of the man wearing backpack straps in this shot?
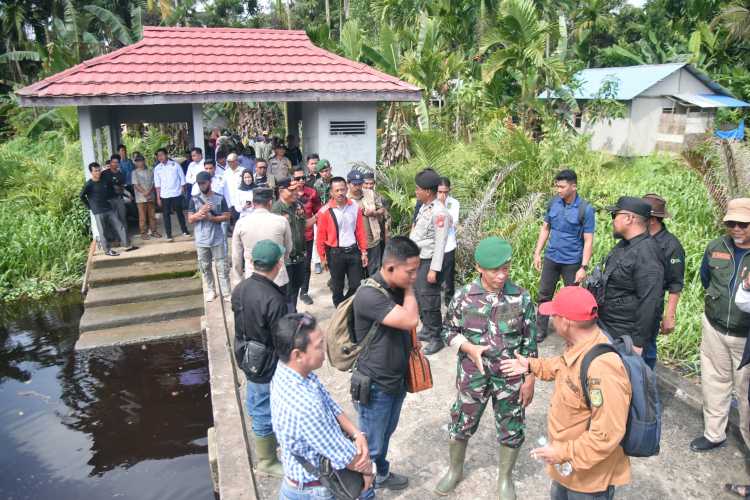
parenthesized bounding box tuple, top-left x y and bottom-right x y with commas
(544, 195, 596, 264)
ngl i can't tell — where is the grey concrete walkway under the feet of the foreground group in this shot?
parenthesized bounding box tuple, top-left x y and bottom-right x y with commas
(256, 274, 750, 500)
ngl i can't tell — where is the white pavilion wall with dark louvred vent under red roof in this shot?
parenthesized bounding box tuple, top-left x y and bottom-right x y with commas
(302, 102, 377, 176)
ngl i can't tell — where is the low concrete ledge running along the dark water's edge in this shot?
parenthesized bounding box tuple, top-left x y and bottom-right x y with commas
(204, 268, 259, 500)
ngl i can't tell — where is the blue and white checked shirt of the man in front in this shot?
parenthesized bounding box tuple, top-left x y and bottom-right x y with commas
(271, 361, 357, 483)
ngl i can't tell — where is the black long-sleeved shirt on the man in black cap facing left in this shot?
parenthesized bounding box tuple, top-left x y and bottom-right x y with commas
(599, 232, 664, 347)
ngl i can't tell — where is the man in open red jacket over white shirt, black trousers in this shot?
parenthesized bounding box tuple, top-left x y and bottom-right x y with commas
(315, 177, 367, 307)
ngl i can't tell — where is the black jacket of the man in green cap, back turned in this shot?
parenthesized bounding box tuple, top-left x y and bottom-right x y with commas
(232, 273, 287, 384)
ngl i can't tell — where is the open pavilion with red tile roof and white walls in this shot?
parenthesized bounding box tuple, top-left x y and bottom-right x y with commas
(17, 27, 421, 176)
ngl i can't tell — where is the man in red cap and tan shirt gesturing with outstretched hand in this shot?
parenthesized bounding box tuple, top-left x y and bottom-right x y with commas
(501, 286, 632, 500)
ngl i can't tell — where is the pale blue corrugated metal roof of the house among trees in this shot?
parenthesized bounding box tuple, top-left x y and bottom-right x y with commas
(539, 63, 732, 101)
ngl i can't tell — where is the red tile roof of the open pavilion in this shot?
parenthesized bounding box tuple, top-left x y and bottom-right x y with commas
(17, 27, 420, 105)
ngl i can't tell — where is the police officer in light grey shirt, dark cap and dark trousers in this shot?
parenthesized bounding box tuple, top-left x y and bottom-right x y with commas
(409, 168, 453, 355)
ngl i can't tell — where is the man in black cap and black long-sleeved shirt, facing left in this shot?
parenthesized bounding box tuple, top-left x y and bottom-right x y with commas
(599, 196, 664, 353)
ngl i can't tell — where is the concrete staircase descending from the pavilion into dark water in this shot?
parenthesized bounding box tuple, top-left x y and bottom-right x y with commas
(76, 235, 204, 350)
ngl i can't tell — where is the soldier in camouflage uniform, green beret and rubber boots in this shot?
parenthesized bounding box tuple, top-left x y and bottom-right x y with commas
(435, 237, 537, 500)
